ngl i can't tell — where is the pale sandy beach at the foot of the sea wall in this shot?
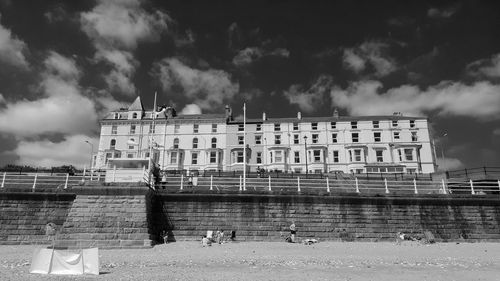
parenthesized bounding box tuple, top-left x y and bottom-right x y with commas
(0, 241, 500, 280)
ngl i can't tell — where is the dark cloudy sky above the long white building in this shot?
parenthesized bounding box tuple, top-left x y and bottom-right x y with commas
(0, 0, 500, 169)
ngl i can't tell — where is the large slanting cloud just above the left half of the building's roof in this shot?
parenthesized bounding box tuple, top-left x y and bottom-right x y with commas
(155, 58, 239, 111)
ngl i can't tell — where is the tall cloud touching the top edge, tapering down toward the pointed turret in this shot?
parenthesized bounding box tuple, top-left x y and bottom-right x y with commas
(80, 0, 171, 96)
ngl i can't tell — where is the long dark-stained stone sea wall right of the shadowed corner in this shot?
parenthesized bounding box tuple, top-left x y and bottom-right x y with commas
(154, 193, 500, 242)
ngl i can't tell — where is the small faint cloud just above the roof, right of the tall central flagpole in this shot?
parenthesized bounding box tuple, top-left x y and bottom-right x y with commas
(284, 75, 332, 113)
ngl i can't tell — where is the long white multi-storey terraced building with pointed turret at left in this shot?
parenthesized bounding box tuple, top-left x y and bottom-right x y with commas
(95, 98, 435, 173)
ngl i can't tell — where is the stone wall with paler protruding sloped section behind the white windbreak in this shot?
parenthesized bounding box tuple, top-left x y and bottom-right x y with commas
(0, 186, 152, 248)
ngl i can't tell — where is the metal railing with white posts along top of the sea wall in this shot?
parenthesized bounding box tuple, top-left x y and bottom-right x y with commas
(0, 172, 500, 195)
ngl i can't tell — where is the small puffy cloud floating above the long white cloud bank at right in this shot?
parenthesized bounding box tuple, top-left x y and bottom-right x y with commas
(343, 41, 398, 77)
